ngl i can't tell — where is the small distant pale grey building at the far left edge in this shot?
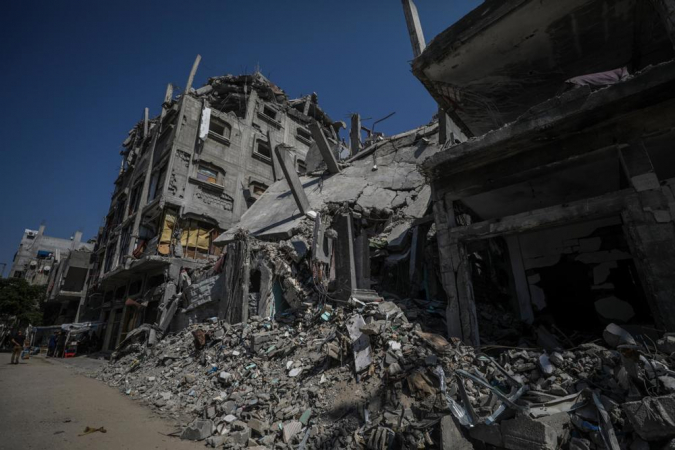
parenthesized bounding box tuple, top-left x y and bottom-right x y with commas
(9, 225, 94, 285)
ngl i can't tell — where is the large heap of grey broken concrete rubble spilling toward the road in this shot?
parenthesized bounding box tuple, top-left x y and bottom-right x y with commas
(98, 298, 675, 450)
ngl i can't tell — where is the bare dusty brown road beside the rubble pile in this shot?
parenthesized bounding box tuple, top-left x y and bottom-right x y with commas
(0, 353, 205, 450)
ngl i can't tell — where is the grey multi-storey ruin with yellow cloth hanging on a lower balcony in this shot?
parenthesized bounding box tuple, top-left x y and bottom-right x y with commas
(86, 57, 342, 349)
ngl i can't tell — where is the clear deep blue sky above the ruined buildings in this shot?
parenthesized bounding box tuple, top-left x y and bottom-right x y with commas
(0, 0, 481, 270)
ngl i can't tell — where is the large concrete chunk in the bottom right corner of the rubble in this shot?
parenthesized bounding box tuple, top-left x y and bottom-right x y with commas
(623, 395, 675, 441)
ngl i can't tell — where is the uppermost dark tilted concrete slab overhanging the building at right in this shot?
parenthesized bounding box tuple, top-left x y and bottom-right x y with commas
(413, 0, 673, 136)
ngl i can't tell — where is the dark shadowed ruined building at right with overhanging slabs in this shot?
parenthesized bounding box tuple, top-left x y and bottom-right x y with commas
(411, 0, 675, 345)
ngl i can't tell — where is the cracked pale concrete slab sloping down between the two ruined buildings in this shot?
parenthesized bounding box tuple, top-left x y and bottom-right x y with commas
(215, 125, 440, 245)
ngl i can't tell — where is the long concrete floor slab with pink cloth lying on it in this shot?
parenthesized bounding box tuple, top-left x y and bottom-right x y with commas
(423, 62, 675, 186)
